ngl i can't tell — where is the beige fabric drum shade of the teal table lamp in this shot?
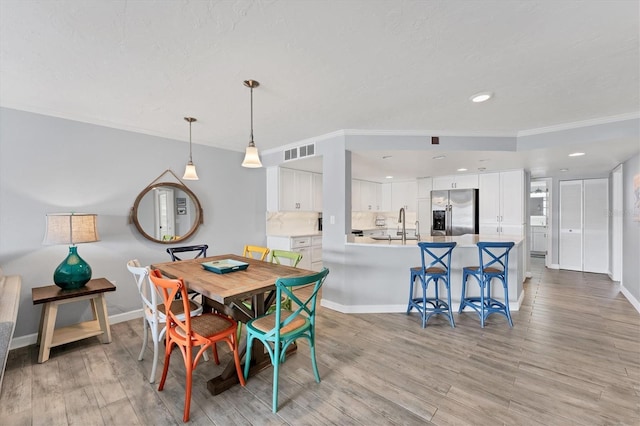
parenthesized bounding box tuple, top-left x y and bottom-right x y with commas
(44, 213, 100, 244)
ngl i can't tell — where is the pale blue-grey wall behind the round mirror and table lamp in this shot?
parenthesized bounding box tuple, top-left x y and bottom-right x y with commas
(0, 108, 266, 337)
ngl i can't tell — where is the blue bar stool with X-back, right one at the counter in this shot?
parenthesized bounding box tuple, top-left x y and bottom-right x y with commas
(458, 242, 514, 328)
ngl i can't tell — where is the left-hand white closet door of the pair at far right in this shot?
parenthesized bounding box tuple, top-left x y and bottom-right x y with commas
(559, 180, 583, 271)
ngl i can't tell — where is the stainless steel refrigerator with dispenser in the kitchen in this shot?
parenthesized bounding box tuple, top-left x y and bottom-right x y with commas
(431, 189, 478, 235)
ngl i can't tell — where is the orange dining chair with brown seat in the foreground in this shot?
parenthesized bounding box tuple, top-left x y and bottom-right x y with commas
(149, 269, 245, 422)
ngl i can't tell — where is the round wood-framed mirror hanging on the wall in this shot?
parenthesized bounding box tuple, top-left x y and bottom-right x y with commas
(131, 182, 202, 244)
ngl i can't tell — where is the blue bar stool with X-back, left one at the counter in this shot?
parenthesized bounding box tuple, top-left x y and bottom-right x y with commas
(407, 242, 456, 328)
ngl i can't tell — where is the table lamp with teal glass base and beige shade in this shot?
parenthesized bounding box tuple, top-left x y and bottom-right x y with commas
(43, 213, 100, 290)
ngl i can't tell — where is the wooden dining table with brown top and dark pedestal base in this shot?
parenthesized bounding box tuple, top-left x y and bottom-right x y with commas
(151, 254, 315, 395)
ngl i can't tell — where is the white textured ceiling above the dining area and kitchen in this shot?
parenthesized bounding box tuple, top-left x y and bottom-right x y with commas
(0, 0, 640, 180)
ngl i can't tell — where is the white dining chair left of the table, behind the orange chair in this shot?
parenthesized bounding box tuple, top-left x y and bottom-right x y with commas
(127, 259, 206, 383)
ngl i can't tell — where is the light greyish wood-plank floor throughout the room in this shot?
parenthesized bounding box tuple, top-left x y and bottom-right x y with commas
(0, 259, 640, 425)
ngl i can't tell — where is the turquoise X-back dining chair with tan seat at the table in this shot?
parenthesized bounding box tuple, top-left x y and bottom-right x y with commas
(244, 268, 329, 413)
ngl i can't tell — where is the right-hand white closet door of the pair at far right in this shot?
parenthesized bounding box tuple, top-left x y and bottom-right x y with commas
(583, 179, 609, 274)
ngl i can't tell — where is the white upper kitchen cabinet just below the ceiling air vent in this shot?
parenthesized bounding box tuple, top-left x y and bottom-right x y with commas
(267, 167, 322, 212)
